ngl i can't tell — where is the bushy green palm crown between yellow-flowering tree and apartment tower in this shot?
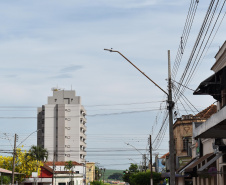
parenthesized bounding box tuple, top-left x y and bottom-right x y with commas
(28, 145, 48, 161)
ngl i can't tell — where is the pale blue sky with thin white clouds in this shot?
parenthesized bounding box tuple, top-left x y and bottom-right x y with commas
(0, 0, 226, 169)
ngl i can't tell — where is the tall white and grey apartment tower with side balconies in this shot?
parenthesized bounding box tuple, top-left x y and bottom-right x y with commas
(37, 89, 86, 163)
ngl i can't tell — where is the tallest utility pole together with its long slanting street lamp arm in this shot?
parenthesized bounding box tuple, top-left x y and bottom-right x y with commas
(104, 49, 175, 185)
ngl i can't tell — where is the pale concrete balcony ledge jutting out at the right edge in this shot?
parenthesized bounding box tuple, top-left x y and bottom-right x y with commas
(193, 106, 226, 139)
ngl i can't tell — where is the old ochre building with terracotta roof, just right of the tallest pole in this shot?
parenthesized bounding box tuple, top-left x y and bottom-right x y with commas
(173, 104, 217, 185)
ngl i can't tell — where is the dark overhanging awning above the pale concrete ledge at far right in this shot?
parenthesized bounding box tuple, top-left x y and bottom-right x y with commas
(193, 66, 226, 101)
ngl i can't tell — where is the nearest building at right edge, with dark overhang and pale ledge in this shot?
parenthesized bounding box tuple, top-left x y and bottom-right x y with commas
(178, 42, 226, 185)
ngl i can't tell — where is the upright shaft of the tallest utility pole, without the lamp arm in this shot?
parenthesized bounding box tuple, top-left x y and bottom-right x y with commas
(168, 50, 175, 185)
